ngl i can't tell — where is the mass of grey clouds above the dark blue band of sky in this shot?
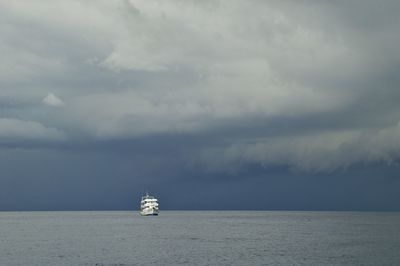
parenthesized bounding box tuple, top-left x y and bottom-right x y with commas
(0, 0, 400, 210)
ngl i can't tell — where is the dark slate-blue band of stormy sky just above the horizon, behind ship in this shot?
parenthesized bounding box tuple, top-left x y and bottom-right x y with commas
(0, 145, 400, 211)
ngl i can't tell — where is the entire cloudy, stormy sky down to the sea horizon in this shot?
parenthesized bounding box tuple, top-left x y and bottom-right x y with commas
(0, 0, 400, 211)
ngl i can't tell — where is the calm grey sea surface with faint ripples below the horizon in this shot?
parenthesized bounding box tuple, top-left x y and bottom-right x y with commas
(0, 211, 400, 265)
